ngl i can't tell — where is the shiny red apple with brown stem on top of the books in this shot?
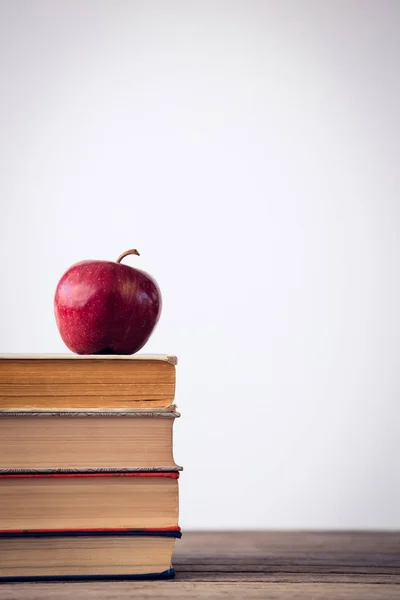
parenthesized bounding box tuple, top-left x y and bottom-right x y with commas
(54, 250, 161, 354)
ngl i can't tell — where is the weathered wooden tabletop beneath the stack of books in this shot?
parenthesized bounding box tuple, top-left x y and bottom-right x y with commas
(0, 532, 400, 600)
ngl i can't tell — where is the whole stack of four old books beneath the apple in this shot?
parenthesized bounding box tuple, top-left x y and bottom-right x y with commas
(0, 355, 181, 580)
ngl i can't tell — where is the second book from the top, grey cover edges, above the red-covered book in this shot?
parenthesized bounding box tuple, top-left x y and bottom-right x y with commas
(0, 411, 181, 473)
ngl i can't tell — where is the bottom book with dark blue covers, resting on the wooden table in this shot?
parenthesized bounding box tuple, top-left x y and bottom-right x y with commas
(0, 529, 181, 581)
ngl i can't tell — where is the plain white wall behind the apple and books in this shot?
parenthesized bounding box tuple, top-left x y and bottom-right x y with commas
(0, 0, 400, 529)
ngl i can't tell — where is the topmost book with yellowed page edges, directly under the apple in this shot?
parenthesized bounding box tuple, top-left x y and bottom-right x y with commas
(0, 354, 177, 411)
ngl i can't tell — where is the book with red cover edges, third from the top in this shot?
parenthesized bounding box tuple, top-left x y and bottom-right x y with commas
(0, 473, 179, 533)
